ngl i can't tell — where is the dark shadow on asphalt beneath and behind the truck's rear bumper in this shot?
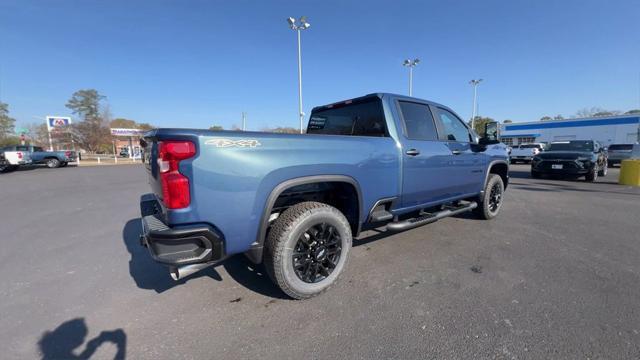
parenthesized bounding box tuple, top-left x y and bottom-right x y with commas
(122, 218, 286, 299)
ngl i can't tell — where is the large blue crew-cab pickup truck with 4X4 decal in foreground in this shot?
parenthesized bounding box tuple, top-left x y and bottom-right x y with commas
(140, 93, 509, 299)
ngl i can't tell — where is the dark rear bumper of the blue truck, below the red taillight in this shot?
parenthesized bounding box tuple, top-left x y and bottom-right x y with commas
(140, 194, 225, 266)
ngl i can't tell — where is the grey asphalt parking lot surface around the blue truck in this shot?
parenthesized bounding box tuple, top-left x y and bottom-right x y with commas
(0, 165, 640, 359)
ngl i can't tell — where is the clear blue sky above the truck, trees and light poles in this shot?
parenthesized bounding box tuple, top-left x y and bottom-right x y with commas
(0, 0, 640, 130)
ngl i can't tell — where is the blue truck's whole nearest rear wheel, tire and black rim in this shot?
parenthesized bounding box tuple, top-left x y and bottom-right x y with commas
(264, 201, 352, 299)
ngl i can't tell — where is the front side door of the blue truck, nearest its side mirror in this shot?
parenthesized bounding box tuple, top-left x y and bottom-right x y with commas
(431, 106, 487, 195)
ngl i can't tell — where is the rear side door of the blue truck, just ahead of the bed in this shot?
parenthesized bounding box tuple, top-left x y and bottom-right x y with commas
(397, 100, 459, 208)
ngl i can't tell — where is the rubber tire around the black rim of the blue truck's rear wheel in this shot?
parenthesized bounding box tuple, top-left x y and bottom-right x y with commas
(264, 201, 352, 299)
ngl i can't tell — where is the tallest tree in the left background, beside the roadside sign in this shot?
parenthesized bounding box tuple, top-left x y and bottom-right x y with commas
(66, 89, 110, 152)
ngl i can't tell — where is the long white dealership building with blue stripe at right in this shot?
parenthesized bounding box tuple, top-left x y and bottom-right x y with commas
(500, 114, 640, 146)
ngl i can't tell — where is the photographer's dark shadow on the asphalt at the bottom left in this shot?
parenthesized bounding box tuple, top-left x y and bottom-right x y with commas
(38, 318, 127, 360)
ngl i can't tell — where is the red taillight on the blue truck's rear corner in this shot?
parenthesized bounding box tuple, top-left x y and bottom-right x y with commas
(158, 141, 196, 209)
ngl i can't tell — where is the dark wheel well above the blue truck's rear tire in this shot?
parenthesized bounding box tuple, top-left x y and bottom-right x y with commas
(271, 181, 360, 236)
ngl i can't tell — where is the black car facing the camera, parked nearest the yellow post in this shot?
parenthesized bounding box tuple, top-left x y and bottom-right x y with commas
(531, 140, 607, 181)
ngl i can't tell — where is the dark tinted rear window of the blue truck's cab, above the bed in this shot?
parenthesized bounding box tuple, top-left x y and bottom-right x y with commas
(307, 98, 389, 137)
